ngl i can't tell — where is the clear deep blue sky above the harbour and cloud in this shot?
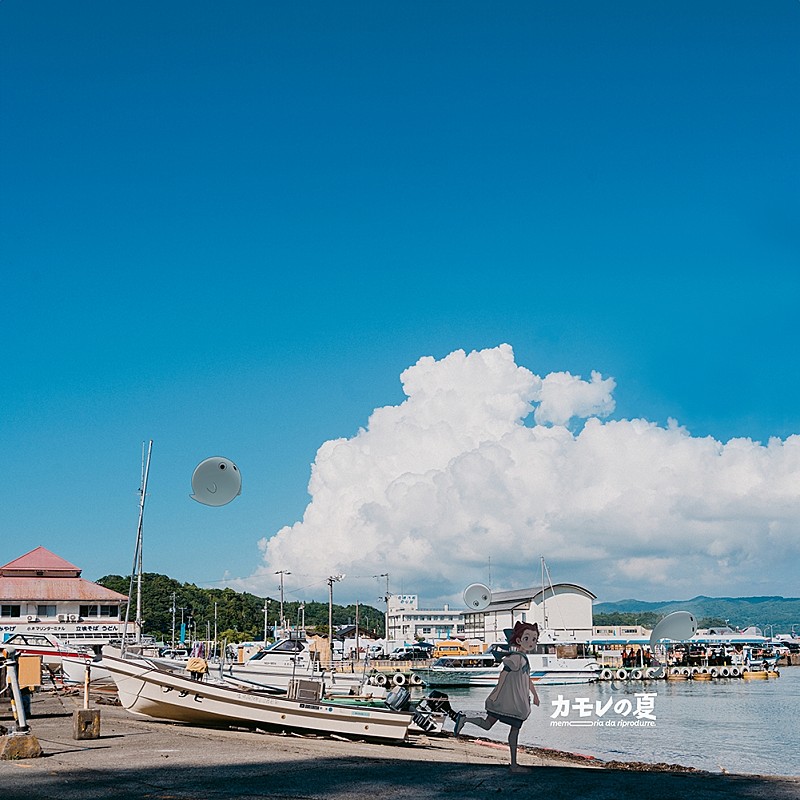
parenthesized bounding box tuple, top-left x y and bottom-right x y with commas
(0, 0, 800, 600)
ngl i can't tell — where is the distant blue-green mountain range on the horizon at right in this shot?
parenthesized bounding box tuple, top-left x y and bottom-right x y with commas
(592, 595, 800, 634)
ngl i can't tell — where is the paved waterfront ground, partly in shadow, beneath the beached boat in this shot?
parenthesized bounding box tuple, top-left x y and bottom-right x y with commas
(0, 693, 800, 800)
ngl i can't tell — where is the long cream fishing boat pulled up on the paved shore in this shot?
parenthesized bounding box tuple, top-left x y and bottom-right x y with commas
(100, 652, 412, 741)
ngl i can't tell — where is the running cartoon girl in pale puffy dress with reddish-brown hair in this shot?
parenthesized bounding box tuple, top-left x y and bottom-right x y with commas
(455, 622, 539, 772)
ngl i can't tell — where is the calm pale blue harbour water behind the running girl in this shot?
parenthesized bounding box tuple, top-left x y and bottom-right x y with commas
(438, 667, 800, 775)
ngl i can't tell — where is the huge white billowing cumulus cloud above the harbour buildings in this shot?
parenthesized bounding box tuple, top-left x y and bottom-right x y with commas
(242, 344, 800, 606)
